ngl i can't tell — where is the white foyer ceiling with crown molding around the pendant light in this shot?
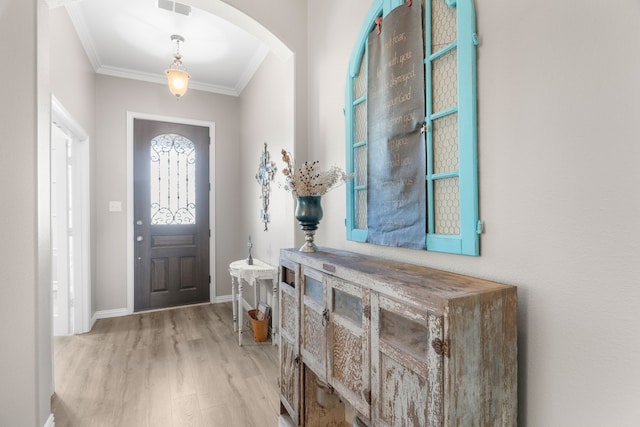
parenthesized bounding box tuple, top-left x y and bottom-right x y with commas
(58, 0, 268, 96)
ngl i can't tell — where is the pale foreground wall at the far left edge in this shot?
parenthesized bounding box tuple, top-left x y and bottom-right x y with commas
(0, 1, 52, 426)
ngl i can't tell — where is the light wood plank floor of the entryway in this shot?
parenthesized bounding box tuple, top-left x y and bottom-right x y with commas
(52, 303, 279, 427)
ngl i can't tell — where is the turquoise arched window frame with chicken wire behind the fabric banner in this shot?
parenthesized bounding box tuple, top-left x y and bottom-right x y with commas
(345, 0, 480, 255)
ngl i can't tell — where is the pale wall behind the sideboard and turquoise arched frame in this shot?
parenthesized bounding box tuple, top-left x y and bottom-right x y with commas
(309, 0, 640, 427)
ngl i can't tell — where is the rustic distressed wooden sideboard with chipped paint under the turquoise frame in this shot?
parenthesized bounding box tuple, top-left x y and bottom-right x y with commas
(279, 248, 517, 427)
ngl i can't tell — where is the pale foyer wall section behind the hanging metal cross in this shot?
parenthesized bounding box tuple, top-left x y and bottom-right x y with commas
(236, 54, 294, 265)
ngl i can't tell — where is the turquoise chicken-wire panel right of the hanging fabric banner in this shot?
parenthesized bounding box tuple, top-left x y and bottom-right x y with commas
(425, 0, 479, 255)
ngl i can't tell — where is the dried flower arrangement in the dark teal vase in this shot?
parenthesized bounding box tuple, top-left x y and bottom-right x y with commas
(281, 148, 349, 197)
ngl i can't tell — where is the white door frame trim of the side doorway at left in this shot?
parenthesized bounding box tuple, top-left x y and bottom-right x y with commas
(50, 95, 93, 334)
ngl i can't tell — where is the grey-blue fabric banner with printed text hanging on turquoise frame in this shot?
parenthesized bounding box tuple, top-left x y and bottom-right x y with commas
(367, 5, 427, 248)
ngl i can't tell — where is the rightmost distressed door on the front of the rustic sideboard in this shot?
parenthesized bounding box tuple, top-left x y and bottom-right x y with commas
(371, 294, 444, 427)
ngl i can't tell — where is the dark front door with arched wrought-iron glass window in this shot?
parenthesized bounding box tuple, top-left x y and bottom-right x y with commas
(133, 119, 210, 311)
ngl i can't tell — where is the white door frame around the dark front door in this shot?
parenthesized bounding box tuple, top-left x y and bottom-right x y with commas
(126, 111, 216, 314)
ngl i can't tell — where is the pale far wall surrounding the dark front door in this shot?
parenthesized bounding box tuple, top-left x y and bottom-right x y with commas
(93, 75, 241, 311)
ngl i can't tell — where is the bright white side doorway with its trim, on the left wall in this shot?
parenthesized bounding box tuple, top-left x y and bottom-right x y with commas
(51, 96, 91, 336)
